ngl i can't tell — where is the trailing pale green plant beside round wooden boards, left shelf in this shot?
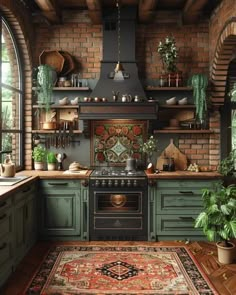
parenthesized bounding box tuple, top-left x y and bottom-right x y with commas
(36, 64, 55, 111)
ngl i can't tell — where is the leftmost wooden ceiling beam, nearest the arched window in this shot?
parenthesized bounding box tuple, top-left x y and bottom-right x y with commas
(35, 0, 62, 24)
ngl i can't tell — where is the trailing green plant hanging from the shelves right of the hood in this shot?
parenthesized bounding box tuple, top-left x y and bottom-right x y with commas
(188, 74, 208, 122)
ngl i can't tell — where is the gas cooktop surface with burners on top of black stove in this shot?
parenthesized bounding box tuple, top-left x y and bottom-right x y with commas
(91, 167, 146, 177)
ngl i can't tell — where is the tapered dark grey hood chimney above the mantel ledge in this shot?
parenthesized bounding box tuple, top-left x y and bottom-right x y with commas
(91, 6, 146, 101)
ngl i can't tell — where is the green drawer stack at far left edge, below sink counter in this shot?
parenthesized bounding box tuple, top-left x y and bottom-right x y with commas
(0, 197, 14, 286)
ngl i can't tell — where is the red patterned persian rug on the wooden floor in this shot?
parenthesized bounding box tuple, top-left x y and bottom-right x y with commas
(25, 246, 218, 295)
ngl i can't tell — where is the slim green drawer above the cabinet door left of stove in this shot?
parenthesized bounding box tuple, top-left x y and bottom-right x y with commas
(40, 179, 80, 190)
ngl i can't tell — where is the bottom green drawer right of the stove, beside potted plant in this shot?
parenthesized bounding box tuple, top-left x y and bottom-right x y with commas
(156, 215, 203, 238)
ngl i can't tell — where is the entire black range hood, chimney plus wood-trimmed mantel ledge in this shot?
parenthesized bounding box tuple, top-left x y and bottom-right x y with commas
(82, 6, 157, 120)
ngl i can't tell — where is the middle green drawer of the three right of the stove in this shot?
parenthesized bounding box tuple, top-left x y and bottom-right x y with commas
(156, 188, 202, 214)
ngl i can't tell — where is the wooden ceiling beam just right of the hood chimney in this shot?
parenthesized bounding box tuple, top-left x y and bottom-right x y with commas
(139, 0, 158, 23)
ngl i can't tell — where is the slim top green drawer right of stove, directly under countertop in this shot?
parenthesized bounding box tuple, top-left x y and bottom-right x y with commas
(157, 179, 219, 192)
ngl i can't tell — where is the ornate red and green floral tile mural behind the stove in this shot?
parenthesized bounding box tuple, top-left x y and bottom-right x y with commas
(91, 120, 147, 166)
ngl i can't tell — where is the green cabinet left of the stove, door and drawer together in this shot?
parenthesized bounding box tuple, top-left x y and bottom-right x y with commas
(40, 179, 87, 240)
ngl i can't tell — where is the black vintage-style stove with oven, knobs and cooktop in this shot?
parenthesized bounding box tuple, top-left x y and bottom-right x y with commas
(89, 167, 148, 241)
